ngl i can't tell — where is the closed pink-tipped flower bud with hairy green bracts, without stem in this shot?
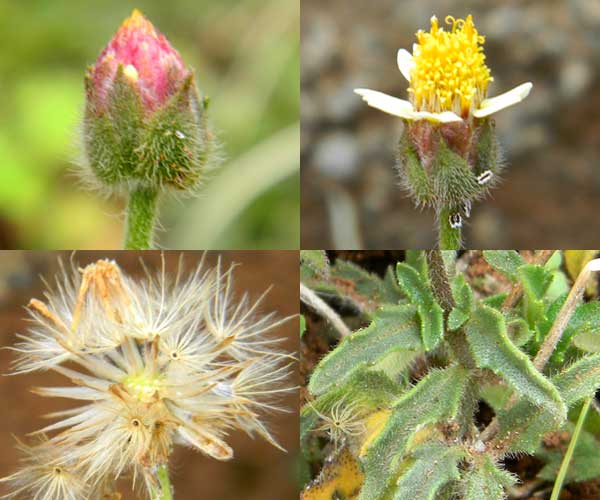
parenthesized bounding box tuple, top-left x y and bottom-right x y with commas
(84, 10, 214, 190)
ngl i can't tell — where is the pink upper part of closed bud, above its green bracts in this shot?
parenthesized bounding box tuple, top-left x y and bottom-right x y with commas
(91, 9, 191, 111)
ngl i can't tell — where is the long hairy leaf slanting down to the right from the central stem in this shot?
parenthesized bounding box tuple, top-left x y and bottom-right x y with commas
(465, 306, 567, 420)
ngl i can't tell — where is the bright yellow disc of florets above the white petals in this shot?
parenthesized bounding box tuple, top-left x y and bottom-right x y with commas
(408, 16, 493, 117)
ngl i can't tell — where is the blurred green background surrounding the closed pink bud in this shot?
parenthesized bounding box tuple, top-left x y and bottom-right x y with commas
(0, 0, 300, 249)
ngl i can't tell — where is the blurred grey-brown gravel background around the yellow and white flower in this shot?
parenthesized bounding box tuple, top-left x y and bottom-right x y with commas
(301, 0, 600, 249)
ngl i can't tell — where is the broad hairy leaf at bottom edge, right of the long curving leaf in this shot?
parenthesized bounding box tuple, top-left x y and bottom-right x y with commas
(393, 443, 465, 500)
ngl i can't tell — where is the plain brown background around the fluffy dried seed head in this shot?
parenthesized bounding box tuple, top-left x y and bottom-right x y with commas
(0, 251, 299, 500)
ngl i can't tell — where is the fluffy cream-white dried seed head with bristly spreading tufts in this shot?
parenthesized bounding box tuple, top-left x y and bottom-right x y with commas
(2, 260, 292, 500)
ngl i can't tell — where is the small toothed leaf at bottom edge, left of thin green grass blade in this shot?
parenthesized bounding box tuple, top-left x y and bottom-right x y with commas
(462, 456, 516, 500)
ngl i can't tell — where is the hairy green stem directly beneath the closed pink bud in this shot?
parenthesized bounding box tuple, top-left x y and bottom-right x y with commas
(125, 186, 158, 250)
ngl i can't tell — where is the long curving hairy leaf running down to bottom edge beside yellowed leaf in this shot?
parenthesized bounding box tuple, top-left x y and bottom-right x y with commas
(359, 366, 469, 500)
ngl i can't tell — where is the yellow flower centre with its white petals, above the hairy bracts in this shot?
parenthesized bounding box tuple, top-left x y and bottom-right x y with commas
(355, 16, 533, 123)
